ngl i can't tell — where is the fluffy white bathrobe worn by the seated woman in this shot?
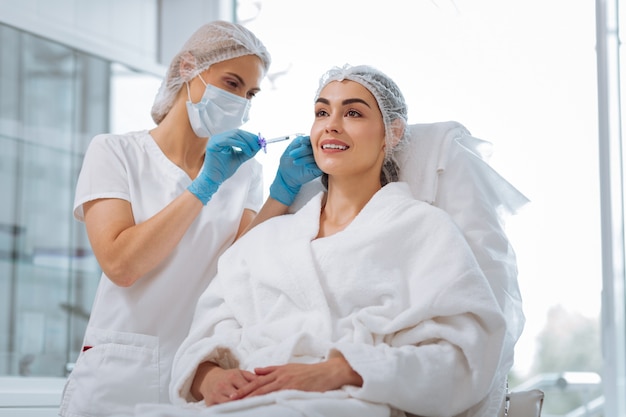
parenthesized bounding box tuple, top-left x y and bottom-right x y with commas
(157, 183, 505, 417)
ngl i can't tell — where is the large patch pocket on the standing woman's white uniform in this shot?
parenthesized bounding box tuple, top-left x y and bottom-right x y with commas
(61, 327, 159, 417)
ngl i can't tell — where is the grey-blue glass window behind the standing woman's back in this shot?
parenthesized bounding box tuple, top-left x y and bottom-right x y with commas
(0, 26, 156, 377)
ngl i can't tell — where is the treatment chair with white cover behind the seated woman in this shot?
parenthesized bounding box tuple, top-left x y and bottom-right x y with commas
(290, 121, 543, 417)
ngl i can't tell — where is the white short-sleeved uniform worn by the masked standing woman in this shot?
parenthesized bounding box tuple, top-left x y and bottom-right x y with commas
(61, 131, 263, 417)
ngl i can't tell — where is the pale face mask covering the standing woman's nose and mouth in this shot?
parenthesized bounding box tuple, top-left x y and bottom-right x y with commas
(187, 75, 250, 138)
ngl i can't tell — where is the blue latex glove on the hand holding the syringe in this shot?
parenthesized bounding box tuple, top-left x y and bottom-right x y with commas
(187, 129, 261, 205)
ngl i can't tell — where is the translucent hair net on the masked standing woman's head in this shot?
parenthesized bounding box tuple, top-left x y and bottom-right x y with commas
(152, 21, 271, 124)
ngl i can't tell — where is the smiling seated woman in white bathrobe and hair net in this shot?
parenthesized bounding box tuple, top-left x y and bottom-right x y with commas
(120, 66, 508, 417)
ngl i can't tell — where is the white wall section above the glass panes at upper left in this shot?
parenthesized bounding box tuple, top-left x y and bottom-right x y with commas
(0, 0, 235, 76)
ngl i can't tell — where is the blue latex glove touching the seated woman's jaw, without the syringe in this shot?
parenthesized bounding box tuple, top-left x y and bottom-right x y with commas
(270, 136, 322, 206)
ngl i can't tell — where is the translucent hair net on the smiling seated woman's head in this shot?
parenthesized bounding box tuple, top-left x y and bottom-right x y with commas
(315, 64, 409, 160)
